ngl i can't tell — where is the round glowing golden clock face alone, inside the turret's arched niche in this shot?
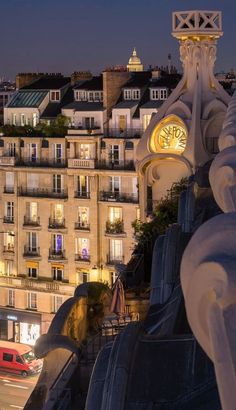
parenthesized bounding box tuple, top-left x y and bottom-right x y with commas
(156, 122, 187, 152)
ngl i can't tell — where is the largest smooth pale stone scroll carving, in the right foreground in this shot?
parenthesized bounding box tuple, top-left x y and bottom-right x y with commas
(181, 213, 236, 410)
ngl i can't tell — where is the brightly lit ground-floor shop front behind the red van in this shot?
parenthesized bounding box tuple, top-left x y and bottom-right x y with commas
(0, 308, 41, 345)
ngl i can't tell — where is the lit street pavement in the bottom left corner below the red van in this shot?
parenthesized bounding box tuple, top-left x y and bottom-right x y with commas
(0, 372, 39, 410)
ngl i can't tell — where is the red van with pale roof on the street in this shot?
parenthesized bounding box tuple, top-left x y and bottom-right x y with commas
(0, 340, 43, 377)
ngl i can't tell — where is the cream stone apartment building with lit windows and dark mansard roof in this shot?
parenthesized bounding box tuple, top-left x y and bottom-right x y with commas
(0, 66, 178, 344)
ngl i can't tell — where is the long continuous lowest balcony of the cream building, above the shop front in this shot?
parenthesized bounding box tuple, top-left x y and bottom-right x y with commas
(0, 275, 75, 296)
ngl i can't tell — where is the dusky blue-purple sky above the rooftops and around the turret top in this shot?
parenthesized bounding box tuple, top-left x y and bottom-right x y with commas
(0, 0, 236, 79)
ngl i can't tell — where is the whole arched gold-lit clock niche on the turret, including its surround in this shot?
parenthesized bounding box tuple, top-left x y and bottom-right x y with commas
(151, 115, 188, 154)
